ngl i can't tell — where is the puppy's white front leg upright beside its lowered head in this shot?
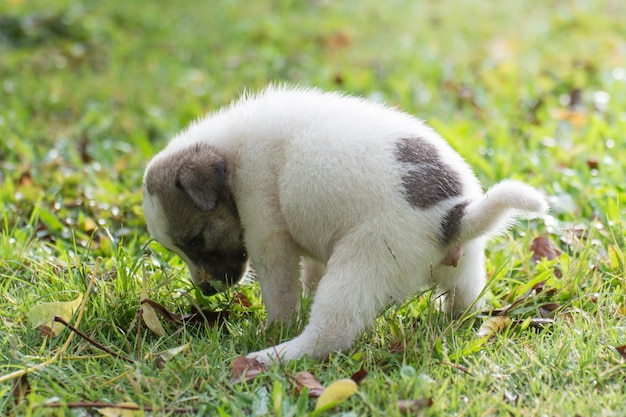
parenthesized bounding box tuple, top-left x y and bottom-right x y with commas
(248, 233, 300, 325)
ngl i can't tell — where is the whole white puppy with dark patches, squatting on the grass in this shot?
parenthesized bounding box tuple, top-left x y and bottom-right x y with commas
(143, 87, 548, 363)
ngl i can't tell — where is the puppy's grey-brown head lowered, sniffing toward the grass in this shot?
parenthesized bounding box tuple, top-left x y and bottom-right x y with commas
(143, 144, 248, 295)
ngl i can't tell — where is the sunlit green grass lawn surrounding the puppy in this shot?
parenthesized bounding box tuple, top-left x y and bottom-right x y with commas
(0, 0, 626, 416)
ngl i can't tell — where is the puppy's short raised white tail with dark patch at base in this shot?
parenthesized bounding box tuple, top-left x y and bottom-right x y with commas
(453, 180, 548, 242)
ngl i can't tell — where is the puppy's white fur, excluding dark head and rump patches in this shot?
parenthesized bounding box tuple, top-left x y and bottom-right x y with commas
(146, 88, 547, 363)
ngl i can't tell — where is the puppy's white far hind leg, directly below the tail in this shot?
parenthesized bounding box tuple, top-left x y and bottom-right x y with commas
(433, 239, 485, 314)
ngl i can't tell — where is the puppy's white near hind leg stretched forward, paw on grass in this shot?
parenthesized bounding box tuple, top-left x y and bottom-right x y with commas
(248, 256, 387, 364)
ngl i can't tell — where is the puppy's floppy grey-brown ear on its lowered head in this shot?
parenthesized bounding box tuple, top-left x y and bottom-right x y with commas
(176, 147, 226, 211)
